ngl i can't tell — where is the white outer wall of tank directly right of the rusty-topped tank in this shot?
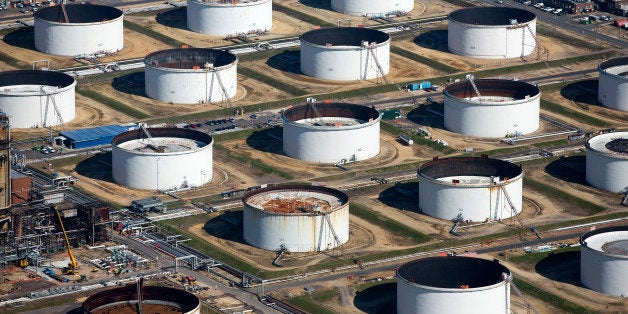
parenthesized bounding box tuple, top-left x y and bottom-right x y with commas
(419, 177, 523, 221)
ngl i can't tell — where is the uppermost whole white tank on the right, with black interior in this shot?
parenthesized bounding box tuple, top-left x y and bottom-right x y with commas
(447, 7, 537, 59)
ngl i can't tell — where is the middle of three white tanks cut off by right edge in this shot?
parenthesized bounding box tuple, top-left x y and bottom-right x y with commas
(586, 132, 628, 193)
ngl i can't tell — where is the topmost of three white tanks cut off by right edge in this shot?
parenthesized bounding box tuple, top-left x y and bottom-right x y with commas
(597, 57, 628, 111)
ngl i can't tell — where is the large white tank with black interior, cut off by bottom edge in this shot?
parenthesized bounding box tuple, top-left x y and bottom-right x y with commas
(397, 256, 512, 314)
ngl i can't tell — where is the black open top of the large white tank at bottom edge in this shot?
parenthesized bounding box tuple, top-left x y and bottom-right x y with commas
(397, 256, 510, 290)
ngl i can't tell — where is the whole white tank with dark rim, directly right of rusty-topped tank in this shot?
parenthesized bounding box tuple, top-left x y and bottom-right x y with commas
(418, 156, 523, 221)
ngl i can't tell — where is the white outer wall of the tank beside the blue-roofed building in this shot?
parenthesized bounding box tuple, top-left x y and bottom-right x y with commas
(111, 144, 213, 190)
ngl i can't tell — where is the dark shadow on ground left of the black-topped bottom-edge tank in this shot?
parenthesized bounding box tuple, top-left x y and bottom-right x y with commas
(353, 282, 397, 314)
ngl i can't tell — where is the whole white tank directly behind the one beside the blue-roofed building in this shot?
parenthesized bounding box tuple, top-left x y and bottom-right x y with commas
(144, 48, 238, 104)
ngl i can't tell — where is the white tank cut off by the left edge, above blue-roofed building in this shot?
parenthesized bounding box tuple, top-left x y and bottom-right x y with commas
(0, 70, 76, 128)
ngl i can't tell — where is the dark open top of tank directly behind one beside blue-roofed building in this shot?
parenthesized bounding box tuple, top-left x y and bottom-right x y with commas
(144, 48, 238, 69)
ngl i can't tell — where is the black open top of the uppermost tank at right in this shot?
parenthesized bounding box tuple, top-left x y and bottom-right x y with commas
(449, 7, 536, 26)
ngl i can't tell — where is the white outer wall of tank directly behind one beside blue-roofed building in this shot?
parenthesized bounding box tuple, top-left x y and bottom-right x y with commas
(144, 64, 238, 104)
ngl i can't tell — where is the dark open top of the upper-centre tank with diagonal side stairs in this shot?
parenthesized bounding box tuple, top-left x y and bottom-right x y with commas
(301, 27, 390, 47)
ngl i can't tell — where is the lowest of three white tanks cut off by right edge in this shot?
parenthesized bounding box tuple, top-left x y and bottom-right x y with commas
(580, 225, 628, 298)
